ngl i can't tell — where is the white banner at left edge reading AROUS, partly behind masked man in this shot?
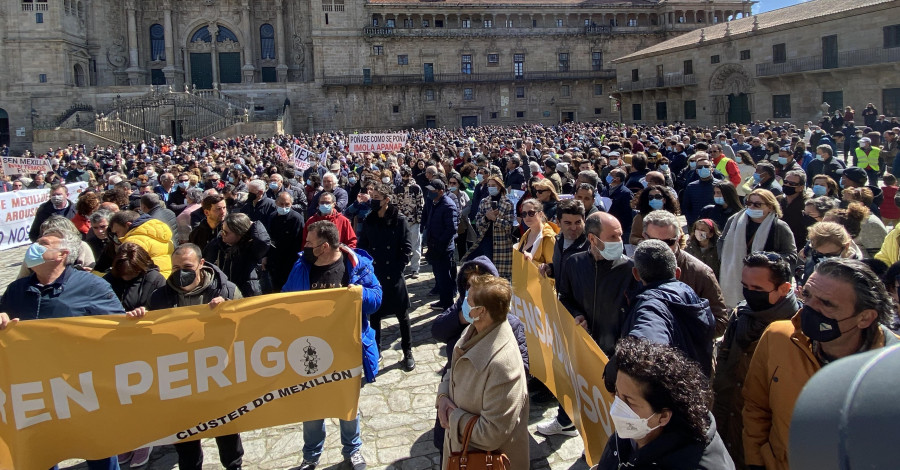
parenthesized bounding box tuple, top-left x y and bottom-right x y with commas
(0, 182, 87, 251)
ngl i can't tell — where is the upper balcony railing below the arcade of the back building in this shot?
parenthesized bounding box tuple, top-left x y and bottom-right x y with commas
(363, 25, 666, 37)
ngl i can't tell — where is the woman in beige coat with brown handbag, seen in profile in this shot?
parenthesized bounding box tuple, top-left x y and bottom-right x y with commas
(436, 275, 530, 469)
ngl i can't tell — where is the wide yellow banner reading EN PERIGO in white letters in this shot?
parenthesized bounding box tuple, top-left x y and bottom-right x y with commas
(0, 287, 362, 470)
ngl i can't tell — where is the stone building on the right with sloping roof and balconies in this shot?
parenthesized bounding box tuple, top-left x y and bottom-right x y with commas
(614, 0, 900, 125)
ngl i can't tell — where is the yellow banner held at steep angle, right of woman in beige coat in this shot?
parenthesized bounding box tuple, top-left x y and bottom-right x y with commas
(511, 251, 613, 465)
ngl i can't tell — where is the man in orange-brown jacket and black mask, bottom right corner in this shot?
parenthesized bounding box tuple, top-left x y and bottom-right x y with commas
(743, 258, 900, 470)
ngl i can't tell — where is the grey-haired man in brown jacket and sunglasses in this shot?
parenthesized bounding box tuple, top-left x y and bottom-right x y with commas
(644, 210, 728, 337)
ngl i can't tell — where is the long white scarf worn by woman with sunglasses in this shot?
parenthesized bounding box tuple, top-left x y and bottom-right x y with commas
(719, 210, 777, 308)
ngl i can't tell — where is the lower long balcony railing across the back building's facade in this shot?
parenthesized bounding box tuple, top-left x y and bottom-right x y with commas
(323, 69, 616, 86)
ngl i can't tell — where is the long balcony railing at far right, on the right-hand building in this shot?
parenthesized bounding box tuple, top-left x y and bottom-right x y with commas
(756, 47, 900, 77)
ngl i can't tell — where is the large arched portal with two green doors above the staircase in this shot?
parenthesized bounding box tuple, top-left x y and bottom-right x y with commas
(188, 25, 241, 89)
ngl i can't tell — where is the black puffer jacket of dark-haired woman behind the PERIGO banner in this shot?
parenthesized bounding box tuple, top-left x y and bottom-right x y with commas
(203, 221, 271, 297)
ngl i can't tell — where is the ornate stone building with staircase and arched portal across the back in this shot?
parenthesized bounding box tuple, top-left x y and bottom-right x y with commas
(0, 0, 752, 150)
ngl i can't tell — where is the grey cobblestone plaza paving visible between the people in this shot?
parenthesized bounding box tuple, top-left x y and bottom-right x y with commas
(0, 247, 588, 470)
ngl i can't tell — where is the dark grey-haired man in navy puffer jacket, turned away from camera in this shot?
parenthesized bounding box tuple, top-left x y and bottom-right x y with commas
(620, 240, 715, 377)
